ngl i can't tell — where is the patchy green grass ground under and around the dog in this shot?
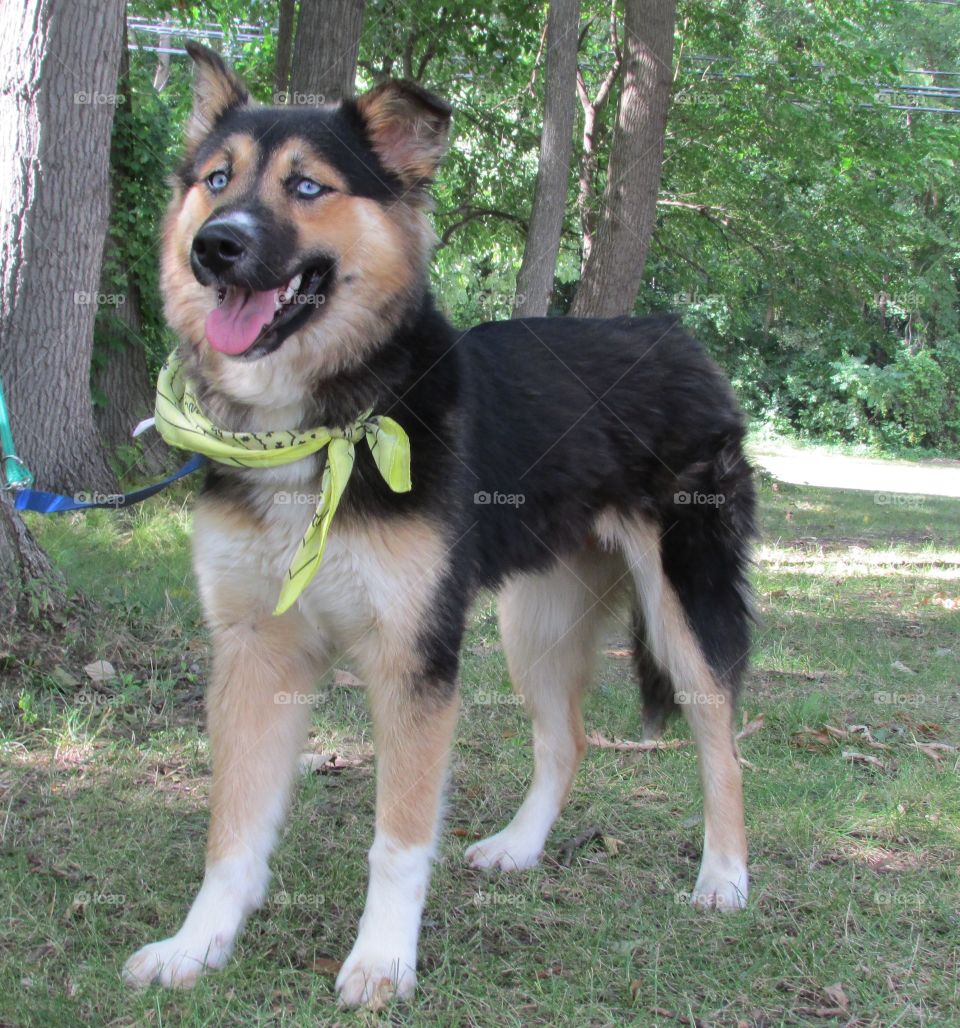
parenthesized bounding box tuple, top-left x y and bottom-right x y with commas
(0, 460, 960, 1026)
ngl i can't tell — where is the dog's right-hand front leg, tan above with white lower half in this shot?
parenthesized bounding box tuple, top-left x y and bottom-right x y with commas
(337, 681, 457, 1007)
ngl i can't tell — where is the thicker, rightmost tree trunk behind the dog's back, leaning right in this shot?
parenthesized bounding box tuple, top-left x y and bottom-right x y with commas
(571, 0, 676, 318)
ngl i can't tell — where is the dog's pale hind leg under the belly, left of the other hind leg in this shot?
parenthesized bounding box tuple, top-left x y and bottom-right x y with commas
(466, 550, 622, 871)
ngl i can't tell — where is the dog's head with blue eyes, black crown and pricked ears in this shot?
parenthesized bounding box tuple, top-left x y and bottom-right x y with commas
(161, 44, 450, 407)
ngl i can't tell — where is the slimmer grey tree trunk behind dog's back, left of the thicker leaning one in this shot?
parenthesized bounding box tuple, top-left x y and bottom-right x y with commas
(513, 0, 580, 318)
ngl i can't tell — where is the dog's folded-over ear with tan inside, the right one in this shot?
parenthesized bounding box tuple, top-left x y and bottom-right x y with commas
(356, 80, 452, 188)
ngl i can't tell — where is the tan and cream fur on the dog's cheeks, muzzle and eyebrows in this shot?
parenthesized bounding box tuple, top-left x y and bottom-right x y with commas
(160, 126, 436, 415)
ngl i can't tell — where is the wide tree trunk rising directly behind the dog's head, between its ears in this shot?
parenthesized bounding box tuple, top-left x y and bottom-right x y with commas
(290, 0, 364, 104)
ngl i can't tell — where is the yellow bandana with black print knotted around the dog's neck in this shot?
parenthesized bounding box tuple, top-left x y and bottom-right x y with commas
(156, 354, 410, 614)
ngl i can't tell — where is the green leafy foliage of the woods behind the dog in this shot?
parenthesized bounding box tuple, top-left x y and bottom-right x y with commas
(112, 0, 960, 450)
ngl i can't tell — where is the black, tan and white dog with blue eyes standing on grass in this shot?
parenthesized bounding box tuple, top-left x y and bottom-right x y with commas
(124, 46, 754, 1005)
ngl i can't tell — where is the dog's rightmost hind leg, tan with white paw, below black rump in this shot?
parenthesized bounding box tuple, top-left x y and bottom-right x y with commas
(600, 517, 748, 910)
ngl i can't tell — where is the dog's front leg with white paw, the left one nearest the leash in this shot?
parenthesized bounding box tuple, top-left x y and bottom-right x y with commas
(123, 599, 316, 988)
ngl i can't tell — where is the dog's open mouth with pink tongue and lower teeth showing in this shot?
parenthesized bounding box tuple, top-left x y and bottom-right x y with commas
(205, 259, 334, 359)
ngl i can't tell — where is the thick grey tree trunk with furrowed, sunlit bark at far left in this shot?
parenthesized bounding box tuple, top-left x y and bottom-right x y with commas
(0, 0, 123, 491)
